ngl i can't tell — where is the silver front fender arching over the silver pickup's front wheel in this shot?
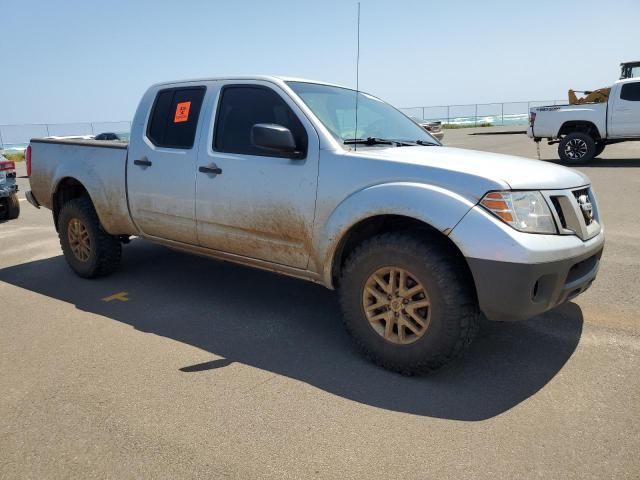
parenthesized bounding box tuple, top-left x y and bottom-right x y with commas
(316, 182, 475, 286)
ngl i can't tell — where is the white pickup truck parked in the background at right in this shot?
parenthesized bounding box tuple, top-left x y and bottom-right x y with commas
(527, 78, 640, 163)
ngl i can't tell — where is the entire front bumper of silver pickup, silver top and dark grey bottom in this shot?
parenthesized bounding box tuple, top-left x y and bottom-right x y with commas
(449, 203, 604, 321)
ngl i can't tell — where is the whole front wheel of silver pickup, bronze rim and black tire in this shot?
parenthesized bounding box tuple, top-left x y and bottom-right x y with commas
(339, 234, 479, 375)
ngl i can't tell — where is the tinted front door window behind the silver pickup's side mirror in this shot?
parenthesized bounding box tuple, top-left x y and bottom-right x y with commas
(213, 85, 308, 157)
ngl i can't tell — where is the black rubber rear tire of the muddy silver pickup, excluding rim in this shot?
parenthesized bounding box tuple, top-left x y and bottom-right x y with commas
(58, 196, 122, 278)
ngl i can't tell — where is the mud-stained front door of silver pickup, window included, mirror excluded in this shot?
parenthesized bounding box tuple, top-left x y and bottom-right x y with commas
(196, 84, 318, 268)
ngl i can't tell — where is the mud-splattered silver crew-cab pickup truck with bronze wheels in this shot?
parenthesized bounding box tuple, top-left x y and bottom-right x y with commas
(27, 77, 604, 374)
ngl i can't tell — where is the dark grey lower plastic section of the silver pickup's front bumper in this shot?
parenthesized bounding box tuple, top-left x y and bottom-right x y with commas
(467, 245, 604, 321)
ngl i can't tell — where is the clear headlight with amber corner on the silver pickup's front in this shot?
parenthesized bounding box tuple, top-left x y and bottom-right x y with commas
(480, 192, 557, 233)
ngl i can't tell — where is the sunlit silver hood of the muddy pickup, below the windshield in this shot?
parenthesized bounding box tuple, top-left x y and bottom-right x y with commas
(352, 146, 590, 190)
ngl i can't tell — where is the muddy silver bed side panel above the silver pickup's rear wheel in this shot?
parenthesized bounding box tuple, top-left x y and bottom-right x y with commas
(30, 138, 137, 235)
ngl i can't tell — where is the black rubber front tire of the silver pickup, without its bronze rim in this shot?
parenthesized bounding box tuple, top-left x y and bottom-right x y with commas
(339, 233, 480, 375)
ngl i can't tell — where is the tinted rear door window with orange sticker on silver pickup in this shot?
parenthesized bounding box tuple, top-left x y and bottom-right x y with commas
(147, 87, 206, 150)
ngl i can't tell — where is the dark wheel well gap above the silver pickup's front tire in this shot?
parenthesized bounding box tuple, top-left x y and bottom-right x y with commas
(331, 215, 475, 295)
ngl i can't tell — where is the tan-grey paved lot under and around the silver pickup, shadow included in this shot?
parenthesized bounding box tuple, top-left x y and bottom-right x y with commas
(0, 133, 640, 479)
